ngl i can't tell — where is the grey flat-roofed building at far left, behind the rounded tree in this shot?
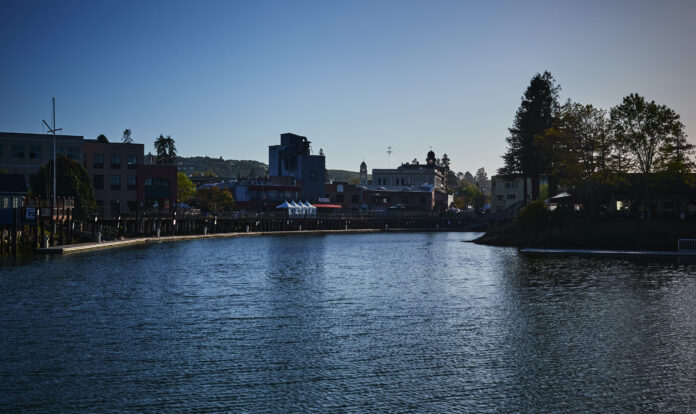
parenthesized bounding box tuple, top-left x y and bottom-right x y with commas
(0, 132, 83, 185)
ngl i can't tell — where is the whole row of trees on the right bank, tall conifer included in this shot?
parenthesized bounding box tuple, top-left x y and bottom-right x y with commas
(498, 71, 694, 204)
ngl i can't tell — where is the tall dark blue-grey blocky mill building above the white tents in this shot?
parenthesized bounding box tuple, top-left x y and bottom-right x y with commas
(268, 133, 326, 201)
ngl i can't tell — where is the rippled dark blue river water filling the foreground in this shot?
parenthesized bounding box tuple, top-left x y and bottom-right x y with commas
(0, 233, 696, 413)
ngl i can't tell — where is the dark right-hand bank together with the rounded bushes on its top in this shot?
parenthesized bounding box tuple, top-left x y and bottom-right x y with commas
(476, 201, 696, 251)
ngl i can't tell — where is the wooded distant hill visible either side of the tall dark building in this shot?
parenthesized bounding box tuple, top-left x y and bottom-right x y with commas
(176, 157, 360, 181)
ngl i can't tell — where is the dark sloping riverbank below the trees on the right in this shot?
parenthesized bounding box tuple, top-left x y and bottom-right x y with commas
(474, 218, 696, 252)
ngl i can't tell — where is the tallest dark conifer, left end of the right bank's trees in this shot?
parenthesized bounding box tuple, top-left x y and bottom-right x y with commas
(498, 71, 561, 205)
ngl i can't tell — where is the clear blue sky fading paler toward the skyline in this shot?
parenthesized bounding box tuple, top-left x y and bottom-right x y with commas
(0, 0, 696, 175)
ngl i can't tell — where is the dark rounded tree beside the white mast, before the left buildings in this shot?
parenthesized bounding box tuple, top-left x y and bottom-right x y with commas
(30, 155, 97, 219)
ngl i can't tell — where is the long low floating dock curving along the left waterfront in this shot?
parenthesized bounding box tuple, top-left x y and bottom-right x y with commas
(34, 229, 462, 254)
